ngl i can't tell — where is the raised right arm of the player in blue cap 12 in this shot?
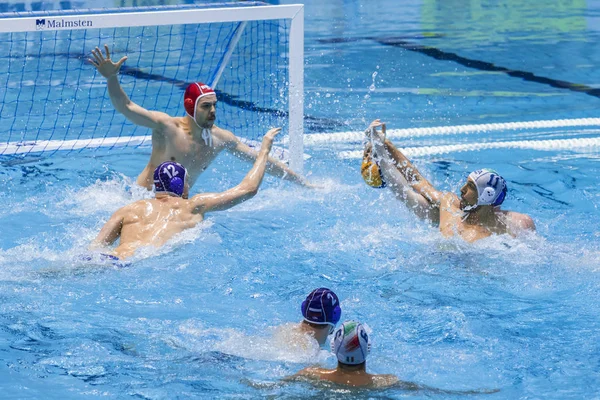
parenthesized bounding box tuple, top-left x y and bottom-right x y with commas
(190, 128, 281, 214)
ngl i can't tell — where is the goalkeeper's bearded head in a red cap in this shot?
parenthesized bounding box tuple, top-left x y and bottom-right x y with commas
(183, 82, 217, 128)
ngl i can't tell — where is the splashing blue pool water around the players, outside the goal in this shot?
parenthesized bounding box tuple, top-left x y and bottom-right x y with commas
(0, 0, 600, 399)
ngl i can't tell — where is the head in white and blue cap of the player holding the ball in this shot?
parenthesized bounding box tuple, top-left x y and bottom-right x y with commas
(460, 168, 507, 211)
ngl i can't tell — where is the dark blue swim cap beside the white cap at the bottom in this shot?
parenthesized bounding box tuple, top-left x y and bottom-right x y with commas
(301, 288, 342, 327)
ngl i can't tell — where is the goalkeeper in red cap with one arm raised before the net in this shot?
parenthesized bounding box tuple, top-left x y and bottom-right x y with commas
(89, 45, 308, 190)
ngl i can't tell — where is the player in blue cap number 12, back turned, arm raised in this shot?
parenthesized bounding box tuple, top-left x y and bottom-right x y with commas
(91, 128, 281, 259)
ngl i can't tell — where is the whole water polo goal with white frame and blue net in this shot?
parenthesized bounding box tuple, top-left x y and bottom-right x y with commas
(0, 2, 304, 172)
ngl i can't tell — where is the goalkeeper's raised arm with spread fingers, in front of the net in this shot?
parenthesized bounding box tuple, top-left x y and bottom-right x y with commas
(88, 45, 169, 129)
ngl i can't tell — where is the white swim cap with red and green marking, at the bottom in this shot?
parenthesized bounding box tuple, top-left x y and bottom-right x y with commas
(331, 321, 371, 365)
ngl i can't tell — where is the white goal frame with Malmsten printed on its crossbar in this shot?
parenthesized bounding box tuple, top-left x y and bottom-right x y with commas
(0, 4, 304, 173)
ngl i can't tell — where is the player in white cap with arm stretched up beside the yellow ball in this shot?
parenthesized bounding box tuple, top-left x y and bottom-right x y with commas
(362, 119, 535, 242)
